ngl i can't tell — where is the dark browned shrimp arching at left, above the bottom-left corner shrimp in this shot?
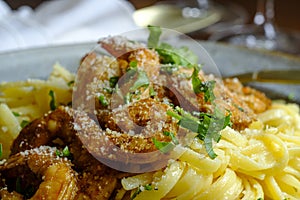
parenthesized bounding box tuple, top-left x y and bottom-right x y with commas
(12, 107, 123, 199)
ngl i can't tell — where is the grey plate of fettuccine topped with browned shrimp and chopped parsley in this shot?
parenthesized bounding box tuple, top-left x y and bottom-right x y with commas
(0, 26, 300, 200)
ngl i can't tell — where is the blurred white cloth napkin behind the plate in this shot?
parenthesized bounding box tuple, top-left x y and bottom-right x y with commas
(0, 0, 137, 52)
